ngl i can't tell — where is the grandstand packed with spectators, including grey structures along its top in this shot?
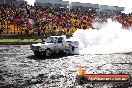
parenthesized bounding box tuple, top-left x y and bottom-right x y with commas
(0, 0, 132, 36)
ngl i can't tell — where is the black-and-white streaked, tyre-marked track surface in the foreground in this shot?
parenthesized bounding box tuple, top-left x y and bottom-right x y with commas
(0, 45, 132, 88)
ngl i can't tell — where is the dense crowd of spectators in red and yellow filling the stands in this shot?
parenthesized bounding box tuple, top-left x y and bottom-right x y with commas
(0, 3, 132, 36)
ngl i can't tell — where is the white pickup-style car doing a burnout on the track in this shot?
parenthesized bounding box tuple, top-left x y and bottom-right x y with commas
(30, 36, 79, 56)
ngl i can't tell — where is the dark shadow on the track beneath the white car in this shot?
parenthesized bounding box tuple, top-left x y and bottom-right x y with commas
(27, 54, 74, 60)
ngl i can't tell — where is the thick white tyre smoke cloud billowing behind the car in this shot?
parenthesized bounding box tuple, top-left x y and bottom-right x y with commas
(72, 19, 132, 54)
